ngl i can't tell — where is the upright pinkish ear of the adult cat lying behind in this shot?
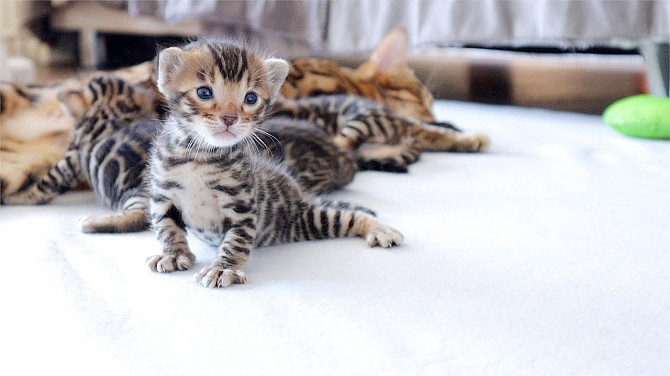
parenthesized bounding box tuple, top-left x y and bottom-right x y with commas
(369, 26, 409, 73)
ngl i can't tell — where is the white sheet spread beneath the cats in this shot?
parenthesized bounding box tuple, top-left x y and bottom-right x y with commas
(0, 101, 670, 375)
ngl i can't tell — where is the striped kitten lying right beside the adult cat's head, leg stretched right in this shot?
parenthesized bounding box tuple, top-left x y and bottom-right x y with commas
(272, 95, 489, 172)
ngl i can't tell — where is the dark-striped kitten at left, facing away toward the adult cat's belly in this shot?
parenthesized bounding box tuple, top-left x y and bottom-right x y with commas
(3, 74, 160, 232)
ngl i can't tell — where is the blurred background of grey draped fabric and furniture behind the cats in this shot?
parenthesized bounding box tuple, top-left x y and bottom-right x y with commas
(0, 0, 670, 113)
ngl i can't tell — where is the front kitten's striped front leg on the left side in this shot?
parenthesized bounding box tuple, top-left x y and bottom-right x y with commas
(147, 194, 195, 273)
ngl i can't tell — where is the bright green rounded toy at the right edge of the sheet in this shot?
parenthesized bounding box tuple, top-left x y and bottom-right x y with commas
(603, 94, 670, 140)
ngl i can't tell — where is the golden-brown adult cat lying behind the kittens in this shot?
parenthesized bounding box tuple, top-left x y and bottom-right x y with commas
(0, 28, 489, 200)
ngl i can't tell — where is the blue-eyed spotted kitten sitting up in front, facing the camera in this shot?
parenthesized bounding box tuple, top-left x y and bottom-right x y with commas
(148, 41, 402, 287)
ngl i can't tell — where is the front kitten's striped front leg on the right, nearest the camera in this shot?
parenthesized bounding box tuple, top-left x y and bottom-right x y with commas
(195, 221, 256, 287)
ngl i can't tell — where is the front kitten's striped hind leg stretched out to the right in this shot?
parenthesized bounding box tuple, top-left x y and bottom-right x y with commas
(298, 199, 403, 248)
